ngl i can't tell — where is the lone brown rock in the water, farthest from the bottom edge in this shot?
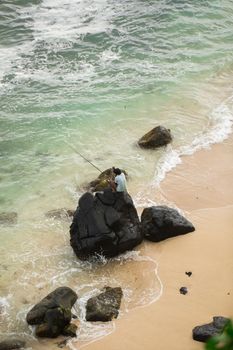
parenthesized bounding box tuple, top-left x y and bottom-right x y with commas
(138, 126, 172, 149)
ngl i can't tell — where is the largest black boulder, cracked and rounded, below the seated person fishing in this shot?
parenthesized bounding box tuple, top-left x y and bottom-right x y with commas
(70, 189, 142, 259)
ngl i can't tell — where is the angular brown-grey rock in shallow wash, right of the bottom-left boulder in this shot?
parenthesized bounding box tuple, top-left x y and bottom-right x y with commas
(86, 287, 123, 322)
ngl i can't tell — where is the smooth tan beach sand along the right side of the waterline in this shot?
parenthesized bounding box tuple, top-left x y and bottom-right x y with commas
(78, 136, 233, 350)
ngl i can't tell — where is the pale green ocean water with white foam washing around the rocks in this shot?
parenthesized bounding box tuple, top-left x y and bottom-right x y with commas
(0, 0, 233, 348)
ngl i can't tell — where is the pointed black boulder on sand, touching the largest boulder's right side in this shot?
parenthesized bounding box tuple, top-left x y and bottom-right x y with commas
(141, 205, 195, 242)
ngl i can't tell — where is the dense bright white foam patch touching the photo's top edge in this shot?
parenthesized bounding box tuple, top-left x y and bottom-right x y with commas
(20, 0, 114, 41)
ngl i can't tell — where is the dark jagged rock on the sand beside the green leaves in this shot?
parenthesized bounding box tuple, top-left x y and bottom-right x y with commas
(193, 316, 229, 342)
